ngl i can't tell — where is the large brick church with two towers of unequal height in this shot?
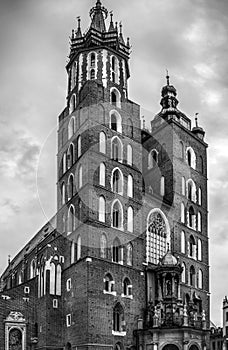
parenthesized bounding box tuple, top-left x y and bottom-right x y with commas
(0, 0, 210, 350)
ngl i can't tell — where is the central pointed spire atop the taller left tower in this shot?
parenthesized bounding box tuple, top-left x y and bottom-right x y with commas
(90, 0, 108, 32)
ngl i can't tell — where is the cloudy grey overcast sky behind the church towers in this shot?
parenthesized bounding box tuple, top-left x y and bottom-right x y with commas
(0, 0, 228, 324)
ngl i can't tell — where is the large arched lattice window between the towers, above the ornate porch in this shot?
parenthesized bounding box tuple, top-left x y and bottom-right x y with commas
(146, 211, 167, 264)
